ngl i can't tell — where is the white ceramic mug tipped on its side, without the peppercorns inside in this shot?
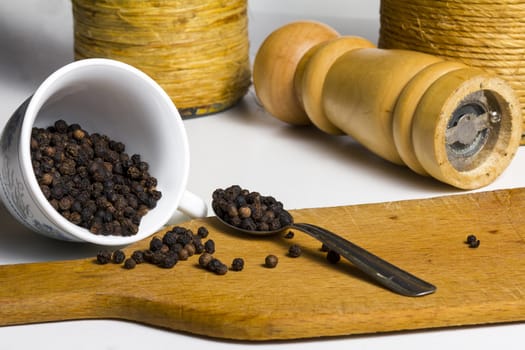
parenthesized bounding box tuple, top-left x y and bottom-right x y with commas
(0, 59, 207, 246)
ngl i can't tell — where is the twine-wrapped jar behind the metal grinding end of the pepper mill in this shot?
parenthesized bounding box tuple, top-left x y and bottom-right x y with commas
(379, 0, 525, 144)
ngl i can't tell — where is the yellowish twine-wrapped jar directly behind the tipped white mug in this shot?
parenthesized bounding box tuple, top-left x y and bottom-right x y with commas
(72, 0, 251, 117)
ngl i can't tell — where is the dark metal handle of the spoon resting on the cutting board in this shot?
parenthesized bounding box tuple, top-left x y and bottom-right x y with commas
(292, 223, 436, 297)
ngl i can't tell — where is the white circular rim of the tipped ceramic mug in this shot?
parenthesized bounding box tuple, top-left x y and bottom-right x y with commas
(19, 58, 189, 246)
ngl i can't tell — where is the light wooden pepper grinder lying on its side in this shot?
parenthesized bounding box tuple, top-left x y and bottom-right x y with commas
(253, 22, 521, 189)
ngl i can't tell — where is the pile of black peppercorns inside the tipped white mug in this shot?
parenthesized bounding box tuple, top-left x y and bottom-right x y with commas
(31, 120, 162, 236)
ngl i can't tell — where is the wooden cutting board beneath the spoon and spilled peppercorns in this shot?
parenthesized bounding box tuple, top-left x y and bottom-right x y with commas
(0, 189, 525, 340)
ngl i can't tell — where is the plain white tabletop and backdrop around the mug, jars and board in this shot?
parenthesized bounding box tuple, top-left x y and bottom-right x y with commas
(0, 0, 525, 350)
